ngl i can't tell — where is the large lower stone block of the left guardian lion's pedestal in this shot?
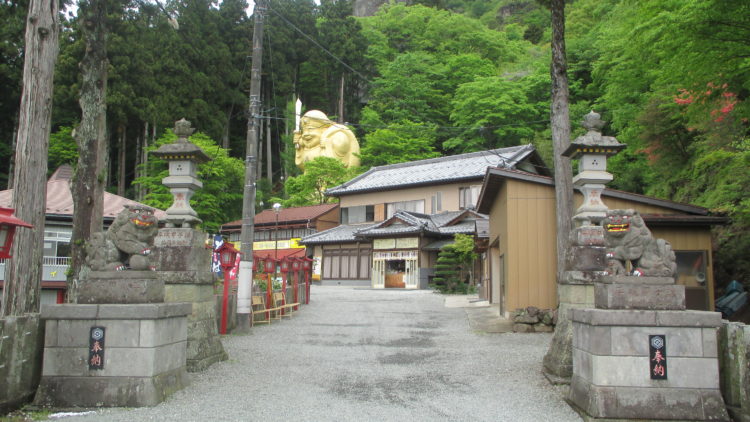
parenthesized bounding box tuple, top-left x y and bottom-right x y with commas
(35, 303, 191, 407)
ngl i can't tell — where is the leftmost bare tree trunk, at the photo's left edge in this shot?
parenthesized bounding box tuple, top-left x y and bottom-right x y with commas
(0, 0, 60, 316)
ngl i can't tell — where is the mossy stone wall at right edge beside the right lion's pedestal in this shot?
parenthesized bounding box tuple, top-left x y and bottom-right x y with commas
(719, 321, 750, 422)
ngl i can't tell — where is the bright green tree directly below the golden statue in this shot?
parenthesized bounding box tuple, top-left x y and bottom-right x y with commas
(282, 157, 355, 208)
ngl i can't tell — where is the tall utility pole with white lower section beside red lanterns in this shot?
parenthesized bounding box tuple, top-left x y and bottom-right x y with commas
(237, 0, 267, 332)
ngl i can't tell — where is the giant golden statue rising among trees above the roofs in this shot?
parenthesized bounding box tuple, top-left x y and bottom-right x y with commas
(294, 110, 359, 171)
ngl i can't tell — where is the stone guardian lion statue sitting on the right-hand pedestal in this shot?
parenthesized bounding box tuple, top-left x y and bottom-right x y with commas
(601, 209, 677, 277)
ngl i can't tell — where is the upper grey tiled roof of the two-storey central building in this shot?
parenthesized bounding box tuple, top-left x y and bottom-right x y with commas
(326, 144, 535, 196)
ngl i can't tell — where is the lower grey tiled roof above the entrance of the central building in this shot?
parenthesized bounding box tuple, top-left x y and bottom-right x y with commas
(301, 211, 487, 245)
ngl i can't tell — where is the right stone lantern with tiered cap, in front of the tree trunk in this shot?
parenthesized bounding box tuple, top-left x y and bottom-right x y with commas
(563, 111, 625, 226)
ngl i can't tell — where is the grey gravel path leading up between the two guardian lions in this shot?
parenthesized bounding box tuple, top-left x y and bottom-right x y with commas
(63, 286, 580, 422)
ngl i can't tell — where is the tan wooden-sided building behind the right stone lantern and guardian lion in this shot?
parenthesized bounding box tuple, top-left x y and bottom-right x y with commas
(477, 168, 726, 315)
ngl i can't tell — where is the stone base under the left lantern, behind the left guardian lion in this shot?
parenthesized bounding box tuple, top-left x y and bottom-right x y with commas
(154, 228, 227, 372)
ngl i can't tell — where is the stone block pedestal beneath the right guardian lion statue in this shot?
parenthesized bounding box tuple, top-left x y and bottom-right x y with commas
(568, 276, 729, 421)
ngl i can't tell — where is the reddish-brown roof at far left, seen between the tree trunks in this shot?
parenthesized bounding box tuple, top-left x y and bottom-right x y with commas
(0, 165, 166, 219)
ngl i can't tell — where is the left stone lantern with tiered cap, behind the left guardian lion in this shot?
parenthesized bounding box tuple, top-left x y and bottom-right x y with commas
(151, 119, 210, 228)
